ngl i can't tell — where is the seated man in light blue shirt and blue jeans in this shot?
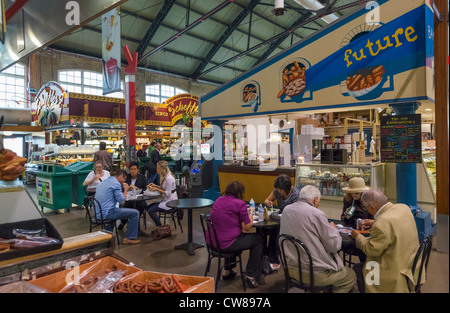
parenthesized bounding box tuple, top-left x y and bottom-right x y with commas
(95, 169, 141, 244)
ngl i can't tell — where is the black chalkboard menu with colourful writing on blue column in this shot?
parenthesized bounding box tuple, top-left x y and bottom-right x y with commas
(380, 114, 422, 163)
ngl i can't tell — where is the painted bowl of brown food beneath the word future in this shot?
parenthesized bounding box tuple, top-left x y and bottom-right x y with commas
(346, 65, 386, 98)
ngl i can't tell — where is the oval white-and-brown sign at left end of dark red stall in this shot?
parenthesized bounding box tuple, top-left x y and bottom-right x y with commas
(32, 81, 66, 127)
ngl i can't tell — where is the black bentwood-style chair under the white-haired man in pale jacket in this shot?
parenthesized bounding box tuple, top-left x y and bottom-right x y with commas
(278, 234, 333, 293)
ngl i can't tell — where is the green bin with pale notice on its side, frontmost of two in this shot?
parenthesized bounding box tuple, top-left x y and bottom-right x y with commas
(36, 164, 73, 210)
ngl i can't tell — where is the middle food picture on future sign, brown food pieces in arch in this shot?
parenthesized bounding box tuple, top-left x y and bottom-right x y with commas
(277, 61, 306, 98)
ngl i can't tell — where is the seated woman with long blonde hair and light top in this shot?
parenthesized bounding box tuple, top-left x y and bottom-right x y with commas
(147, 161, 178, 226)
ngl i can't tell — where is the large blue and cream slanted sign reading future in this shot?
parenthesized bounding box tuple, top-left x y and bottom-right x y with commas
(200, 0, 434, 120)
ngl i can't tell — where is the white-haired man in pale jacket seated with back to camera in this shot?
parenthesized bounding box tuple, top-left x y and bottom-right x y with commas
(280, 186, 356, 293)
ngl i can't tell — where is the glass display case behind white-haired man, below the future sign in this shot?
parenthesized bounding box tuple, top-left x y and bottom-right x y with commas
(295, 163, 385, 200)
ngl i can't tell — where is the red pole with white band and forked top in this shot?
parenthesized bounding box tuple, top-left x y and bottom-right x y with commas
(123, 46, 138, 165)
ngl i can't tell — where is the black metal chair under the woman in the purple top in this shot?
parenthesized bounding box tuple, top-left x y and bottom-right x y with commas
(200, 213, 247, 291)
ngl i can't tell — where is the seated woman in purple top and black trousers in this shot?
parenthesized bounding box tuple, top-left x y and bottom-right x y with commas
(210, 181, 264, 288)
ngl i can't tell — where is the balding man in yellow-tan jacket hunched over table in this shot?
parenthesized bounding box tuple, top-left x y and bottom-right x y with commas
(351, 189, 419, 293)
